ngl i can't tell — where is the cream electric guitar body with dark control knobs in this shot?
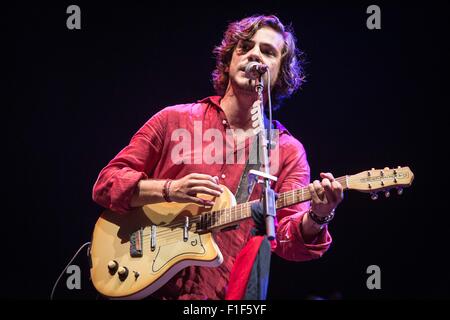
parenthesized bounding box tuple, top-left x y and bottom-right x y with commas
(90, 186, 236, 299)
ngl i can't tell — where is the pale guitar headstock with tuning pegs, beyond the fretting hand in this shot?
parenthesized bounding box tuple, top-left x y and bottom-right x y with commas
(347, 167, 414, 200)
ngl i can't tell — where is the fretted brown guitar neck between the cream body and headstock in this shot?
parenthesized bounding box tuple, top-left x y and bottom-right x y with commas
(206, 176, 348, 231)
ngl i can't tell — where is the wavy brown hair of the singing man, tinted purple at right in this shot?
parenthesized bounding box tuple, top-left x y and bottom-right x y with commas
(212, 15, 305, 107)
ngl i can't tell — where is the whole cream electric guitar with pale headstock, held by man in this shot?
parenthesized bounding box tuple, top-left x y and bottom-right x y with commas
(90, 167, 414, 299)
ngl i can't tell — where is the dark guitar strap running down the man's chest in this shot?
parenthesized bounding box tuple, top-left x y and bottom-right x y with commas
(235, 115, 276, 204)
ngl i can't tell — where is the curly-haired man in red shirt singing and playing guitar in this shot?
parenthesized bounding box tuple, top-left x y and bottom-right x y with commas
(93, 16, 343, 299)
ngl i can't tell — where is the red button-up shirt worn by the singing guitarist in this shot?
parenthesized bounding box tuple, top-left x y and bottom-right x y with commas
(93, 96, 331, 299)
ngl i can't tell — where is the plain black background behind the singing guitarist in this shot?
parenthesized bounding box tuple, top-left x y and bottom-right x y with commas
(1, 1, 450, 299)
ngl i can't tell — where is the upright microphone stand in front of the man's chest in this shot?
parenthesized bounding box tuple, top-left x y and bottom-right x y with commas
(256, 74, 276, 240)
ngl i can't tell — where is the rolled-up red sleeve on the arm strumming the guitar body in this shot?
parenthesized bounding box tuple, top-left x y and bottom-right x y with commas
(92, 110, 167, 213)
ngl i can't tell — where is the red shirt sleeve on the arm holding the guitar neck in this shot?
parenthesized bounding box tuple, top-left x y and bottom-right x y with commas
(274, 140, 332, 261)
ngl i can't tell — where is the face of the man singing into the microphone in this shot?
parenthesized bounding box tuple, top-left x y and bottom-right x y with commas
(229, 27, 284, 92)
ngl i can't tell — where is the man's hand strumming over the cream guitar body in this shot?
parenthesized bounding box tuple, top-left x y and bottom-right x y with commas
(169, 173, 223, 206)
